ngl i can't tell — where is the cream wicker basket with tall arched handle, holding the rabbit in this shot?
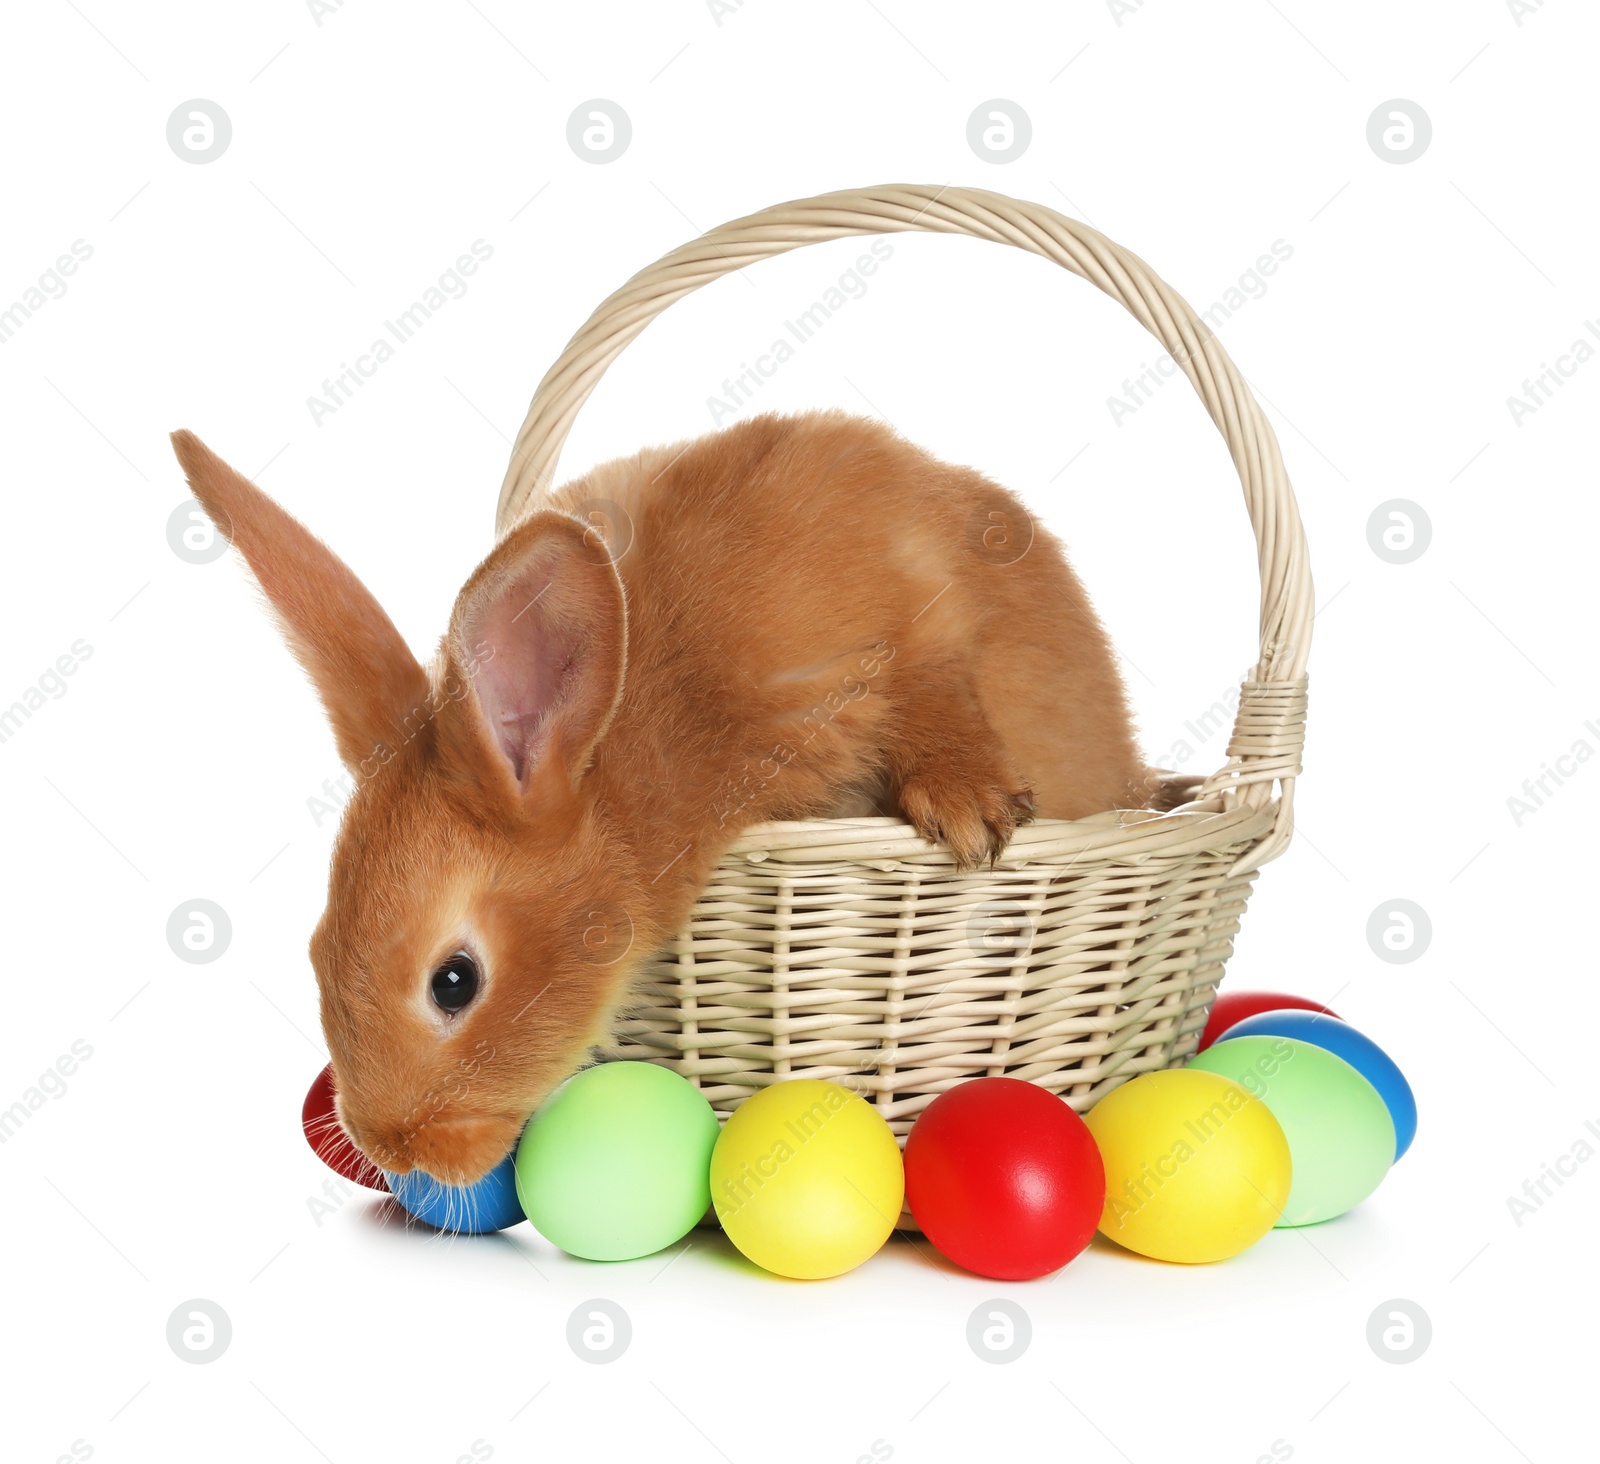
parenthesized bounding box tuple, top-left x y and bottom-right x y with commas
(498, 186, 1312, 1136)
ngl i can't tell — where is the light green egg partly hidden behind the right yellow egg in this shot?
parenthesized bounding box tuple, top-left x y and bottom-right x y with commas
(1189, 1037, 1395, 1227)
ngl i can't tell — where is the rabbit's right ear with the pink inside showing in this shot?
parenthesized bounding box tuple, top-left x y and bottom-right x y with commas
(450, 510, 627, 792)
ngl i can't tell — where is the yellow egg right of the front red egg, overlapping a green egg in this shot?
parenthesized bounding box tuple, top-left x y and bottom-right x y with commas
(1085, 1067, 1291, 1262)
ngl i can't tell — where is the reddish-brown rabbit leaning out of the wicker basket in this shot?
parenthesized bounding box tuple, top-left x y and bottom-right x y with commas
(173, 413, 1163, 1184)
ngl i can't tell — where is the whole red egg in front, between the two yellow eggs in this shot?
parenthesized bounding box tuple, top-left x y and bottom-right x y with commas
(906, 1078, 1106, 1282)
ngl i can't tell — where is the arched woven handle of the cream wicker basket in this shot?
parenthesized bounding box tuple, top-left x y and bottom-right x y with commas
(496, 184, 1312, 866)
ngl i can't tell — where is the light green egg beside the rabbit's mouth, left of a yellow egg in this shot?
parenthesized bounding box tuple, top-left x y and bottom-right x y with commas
(517, 1062, 718, 1261)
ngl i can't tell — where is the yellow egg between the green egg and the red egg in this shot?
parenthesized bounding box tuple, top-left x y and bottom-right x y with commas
(710, 1078, 906, 1280)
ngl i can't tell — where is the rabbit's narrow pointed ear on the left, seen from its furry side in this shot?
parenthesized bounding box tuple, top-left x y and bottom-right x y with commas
(173, 432, 429, 771)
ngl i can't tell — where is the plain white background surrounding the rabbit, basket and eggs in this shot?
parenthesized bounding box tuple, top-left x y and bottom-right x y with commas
(0, 0, 1600, 1464)
